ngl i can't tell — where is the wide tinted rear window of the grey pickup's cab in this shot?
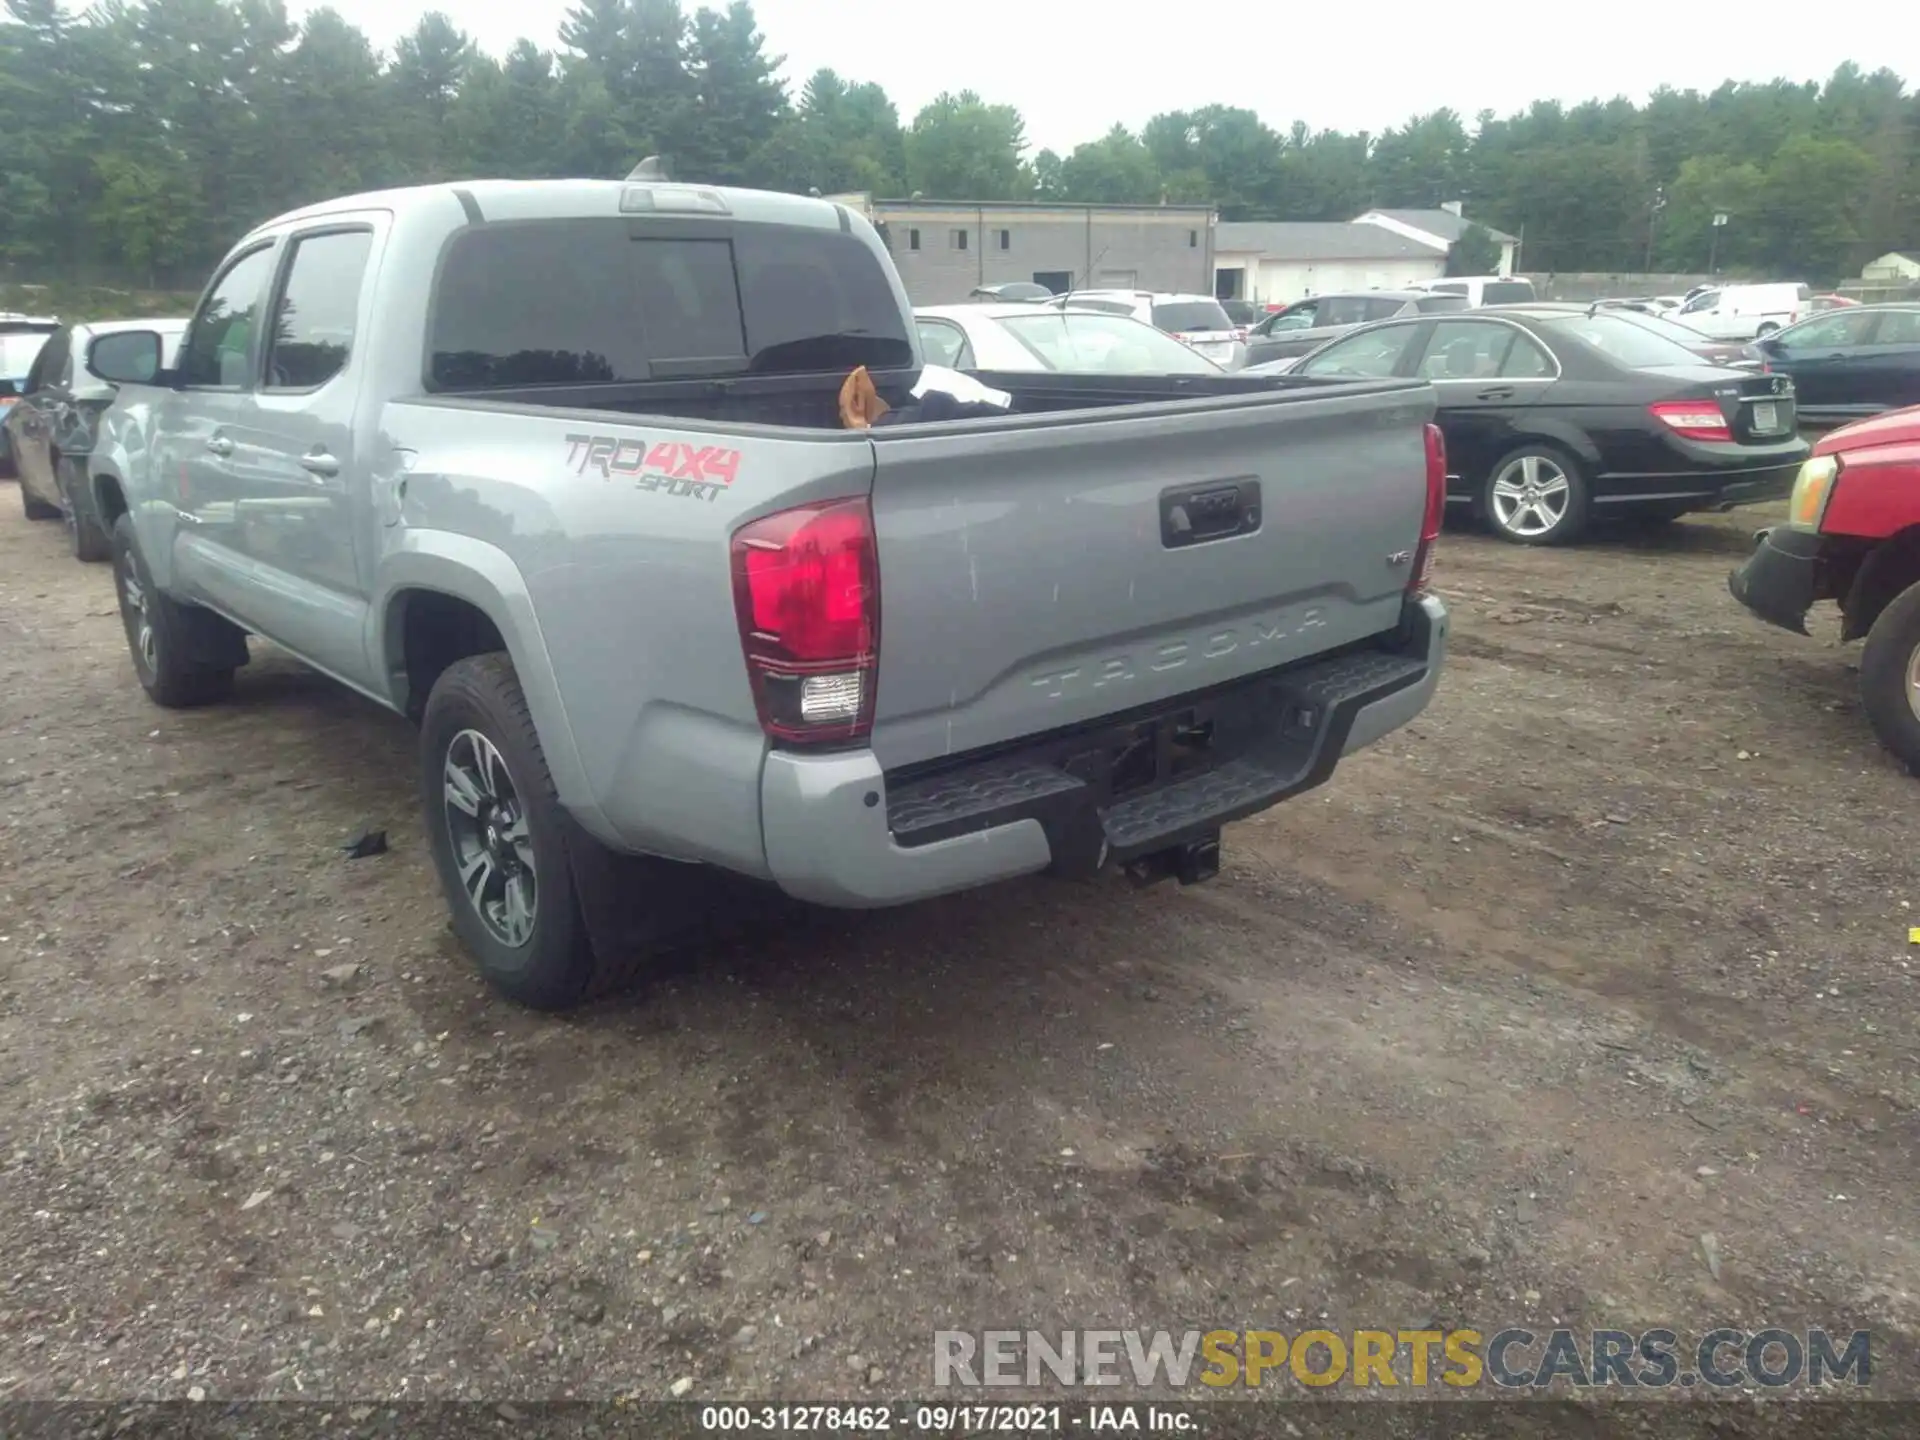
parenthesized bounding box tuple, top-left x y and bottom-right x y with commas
(426, 219, 914, 390)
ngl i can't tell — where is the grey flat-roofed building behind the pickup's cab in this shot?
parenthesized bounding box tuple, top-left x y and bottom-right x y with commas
(831, 194, 1215, 305)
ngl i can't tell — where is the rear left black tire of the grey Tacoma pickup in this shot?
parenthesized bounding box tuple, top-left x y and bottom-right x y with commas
(420, 653, 601, 1010)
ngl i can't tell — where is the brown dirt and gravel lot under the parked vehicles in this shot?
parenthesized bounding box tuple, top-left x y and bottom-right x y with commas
(0, 486, 1920, 1398)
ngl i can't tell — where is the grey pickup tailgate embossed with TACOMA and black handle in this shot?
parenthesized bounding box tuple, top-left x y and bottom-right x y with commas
(872, 382, 1434, 770)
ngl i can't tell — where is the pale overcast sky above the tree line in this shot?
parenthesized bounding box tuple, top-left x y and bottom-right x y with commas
(290, 0, 1889, 154)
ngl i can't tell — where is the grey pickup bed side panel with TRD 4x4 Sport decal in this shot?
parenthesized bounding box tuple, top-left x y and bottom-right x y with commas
(374, 399, 874, 874)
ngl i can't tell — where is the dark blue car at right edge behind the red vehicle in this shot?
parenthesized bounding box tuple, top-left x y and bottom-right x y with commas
(1747, 301, 1920, 424)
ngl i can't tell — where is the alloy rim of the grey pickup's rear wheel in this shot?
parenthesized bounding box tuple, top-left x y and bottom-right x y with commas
(444, 730, 540, 948)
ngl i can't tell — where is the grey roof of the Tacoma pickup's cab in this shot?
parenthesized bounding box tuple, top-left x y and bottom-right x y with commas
(248, 180, 852, 236)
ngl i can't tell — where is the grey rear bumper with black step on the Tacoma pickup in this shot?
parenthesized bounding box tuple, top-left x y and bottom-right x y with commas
(760, 597, 1448, 908)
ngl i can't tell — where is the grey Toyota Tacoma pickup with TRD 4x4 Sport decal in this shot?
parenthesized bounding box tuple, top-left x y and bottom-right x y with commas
(88, 180, 1446, 1008)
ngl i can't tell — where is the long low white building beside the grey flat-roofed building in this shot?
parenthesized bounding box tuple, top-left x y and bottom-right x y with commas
(1213, 221, 1446, 305)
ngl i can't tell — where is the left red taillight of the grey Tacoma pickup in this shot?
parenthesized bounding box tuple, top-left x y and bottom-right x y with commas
(733, 497, 879, 743)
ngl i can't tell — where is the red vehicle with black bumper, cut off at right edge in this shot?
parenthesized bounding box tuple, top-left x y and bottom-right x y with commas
(1728, 405, 1920, 776)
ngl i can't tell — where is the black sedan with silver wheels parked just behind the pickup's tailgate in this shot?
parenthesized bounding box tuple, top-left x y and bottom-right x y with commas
(1256, 307, 1809, 545)
